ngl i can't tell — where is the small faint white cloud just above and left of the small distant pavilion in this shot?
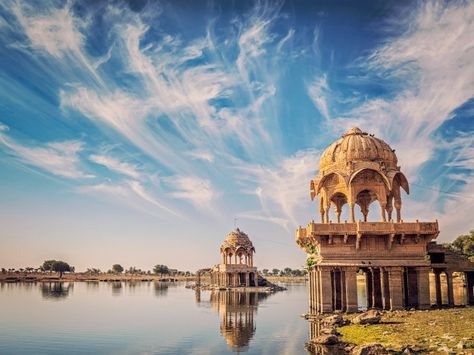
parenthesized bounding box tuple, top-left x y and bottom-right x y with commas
(170, 176, 219, 209)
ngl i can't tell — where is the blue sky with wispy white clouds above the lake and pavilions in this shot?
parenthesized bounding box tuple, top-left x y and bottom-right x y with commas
(0, 0, 474, 271)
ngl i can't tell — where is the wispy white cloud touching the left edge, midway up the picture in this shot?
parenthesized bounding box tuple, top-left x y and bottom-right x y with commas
(0, 129, 93, 179)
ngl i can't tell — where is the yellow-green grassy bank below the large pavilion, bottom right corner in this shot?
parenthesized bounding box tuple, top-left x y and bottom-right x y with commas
(338, 307, 474, 354)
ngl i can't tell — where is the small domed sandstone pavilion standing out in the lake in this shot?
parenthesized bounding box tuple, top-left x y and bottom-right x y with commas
(210, 228, 258, 288)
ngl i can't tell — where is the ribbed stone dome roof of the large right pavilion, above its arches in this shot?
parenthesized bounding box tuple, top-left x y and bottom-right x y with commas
(319, 127, 398, 171)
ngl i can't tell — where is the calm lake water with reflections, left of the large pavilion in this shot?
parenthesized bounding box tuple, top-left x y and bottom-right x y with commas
(0, 282, 309, 354)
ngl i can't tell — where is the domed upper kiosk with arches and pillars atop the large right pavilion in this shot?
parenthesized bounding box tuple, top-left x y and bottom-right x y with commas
(310, 127, 409, 223)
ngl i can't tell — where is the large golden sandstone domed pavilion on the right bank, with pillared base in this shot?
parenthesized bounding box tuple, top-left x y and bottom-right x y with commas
(296, 128, 474, 313)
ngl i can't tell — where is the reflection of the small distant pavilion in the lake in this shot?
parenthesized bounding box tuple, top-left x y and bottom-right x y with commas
(196, 291, 269, 351)
